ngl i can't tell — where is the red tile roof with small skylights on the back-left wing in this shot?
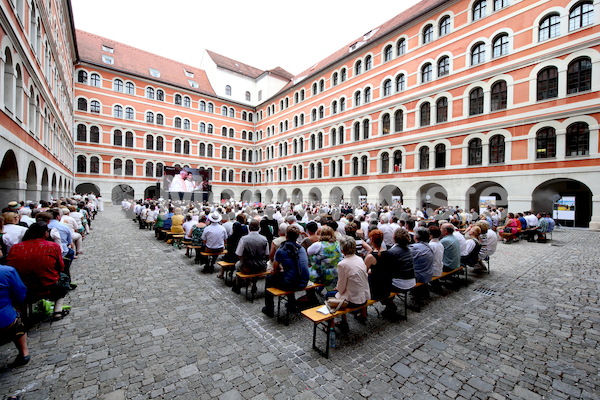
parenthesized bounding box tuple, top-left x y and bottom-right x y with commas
(76, 30, 215, 96)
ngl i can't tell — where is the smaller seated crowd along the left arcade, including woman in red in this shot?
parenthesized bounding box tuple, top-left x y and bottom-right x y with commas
(0, 195, 103, 367)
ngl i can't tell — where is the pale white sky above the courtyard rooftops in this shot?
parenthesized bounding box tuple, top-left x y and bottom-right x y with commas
(71, 0, 419, 75)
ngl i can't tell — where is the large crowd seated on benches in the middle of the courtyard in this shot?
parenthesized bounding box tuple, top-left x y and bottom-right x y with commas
(129, 201, 554, 329)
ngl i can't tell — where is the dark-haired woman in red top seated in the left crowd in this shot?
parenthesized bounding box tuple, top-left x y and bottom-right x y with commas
(7, 222, 66, 319)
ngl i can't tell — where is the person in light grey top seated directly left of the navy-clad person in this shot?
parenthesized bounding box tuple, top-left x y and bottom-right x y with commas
(231, 219, 269, 294)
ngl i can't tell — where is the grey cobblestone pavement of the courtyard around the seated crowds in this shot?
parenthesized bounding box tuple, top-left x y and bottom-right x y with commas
(0, 207, 600, 400)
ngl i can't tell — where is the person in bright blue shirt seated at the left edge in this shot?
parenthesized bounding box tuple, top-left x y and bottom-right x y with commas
(0, 265, 30, 367)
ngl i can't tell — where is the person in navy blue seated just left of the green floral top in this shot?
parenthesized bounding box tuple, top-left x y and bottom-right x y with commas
(262, 224, 309, 317)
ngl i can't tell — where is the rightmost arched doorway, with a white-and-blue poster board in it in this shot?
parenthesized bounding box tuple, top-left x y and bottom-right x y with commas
(531, 178, 592, 228)
